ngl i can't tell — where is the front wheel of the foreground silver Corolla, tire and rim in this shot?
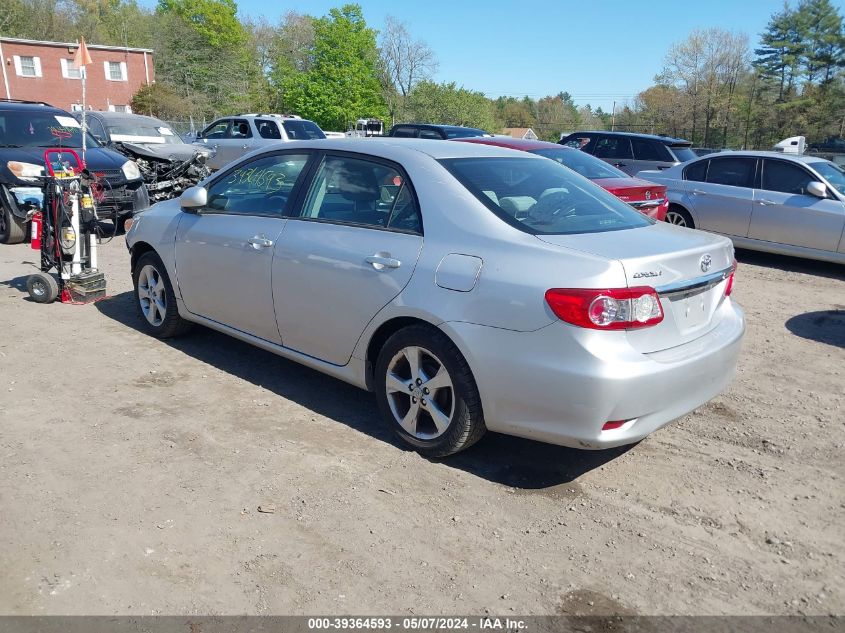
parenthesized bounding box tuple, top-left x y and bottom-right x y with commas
(132, 251, 191, 339)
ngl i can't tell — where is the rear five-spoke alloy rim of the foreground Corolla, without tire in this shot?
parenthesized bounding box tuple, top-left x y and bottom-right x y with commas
(385, 346, 455, 440)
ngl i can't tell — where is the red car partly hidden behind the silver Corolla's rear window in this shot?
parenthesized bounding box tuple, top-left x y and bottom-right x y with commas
(453, 136, 669, 222)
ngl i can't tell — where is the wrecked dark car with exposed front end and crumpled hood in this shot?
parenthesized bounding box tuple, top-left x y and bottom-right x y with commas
(74, 112, 211, 203)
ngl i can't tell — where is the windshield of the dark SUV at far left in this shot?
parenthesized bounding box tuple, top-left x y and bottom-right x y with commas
(0, 110, 100, 147)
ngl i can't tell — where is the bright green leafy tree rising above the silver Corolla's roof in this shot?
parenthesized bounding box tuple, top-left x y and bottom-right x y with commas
(273, 4, 387, 130)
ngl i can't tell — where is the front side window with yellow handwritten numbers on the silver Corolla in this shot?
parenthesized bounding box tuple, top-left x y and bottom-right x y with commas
(206, 154, 309, 217)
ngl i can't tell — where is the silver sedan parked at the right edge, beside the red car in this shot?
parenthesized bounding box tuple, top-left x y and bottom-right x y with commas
(637, 152, 845, 264)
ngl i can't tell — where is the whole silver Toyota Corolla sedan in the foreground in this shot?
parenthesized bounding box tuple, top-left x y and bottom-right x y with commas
(126, 138, 745, 456)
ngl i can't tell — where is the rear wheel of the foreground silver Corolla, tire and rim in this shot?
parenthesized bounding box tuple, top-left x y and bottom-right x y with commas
(375, 325, 487, 457)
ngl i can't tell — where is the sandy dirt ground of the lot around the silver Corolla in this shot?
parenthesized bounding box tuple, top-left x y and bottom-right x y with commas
(0, 238, 845, 615)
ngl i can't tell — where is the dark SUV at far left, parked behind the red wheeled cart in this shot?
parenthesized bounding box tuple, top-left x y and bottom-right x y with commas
(0, 99, 150, 244)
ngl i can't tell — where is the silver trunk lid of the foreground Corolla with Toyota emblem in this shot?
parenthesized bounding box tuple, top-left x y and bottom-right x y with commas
(537, 222, 734, 353)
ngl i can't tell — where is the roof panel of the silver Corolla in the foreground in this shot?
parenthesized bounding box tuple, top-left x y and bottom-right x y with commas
(244, 136, 540, 161)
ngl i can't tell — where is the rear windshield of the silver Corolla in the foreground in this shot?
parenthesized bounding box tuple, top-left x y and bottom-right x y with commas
(440, 157, 653, 235)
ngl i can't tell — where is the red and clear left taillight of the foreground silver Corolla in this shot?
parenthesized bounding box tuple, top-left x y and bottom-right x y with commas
(546, 286, 663, 330)
